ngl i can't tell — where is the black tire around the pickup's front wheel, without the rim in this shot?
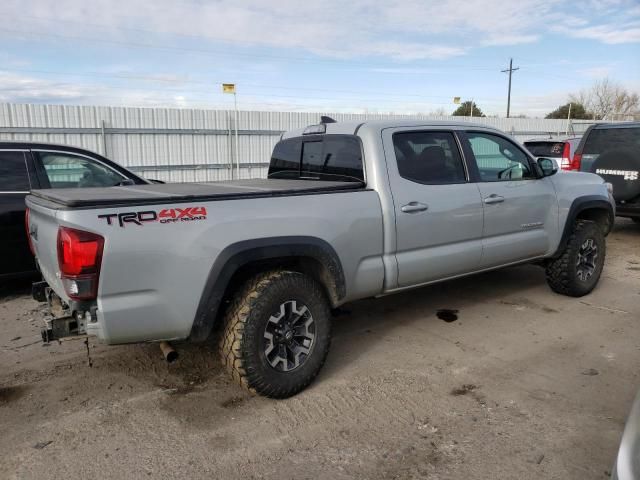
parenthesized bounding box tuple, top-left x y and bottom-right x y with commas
(546, 220, 606, 297)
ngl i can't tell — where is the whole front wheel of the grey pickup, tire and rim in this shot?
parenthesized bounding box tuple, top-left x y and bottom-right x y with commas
(546, 220, 606, 297)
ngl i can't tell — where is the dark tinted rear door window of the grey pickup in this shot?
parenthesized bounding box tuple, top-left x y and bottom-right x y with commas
(393, 132, 466, 185)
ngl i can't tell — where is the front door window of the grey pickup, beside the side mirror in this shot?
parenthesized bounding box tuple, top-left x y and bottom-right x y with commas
(467, 132, 536, 182)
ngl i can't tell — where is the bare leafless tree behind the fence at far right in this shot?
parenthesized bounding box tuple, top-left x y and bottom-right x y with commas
(569, 78, 640, 120)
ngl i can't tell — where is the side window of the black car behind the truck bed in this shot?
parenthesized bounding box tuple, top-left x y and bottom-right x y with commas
(33, 152, 126, 188)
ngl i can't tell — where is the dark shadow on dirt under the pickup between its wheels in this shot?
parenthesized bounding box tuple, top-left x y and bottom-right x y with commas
(320, 265, 553, 377)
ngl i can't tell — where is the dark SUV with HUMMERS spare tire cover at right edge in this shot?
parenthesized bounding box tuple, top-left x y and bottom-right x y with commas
(569, 122, 640, 223)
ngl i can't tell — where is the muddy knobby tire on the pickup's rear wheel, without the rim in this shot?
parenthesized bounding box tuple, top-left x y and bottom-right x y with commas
(220, 270, 331, 398)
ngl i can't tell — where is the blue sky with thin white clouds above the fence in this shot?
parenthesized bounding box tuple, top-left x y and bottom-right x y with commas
(0, 0, 640, 117)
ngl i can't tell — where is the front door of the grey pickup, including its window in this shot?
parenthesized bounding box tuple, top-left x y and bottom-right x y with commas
(460, 131, 558, 268)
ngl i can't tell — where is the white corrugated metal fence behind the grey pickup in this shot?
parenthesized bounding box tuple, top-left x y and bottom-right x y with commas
(0, 104, 592, 182)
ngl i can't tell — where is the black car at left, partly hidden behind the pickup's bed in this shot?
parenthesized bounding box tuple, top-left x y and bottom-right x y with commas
(0, 141, 150, 280)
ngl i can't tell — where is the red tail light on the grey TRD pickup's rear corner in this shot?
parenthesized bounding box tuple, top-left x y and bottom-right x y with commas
(58, 227, 104, 300)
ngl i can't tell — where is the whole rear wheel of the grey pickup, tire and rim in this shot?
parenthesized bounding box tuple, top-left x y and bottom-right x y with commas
(221, 270, 331, 398)
